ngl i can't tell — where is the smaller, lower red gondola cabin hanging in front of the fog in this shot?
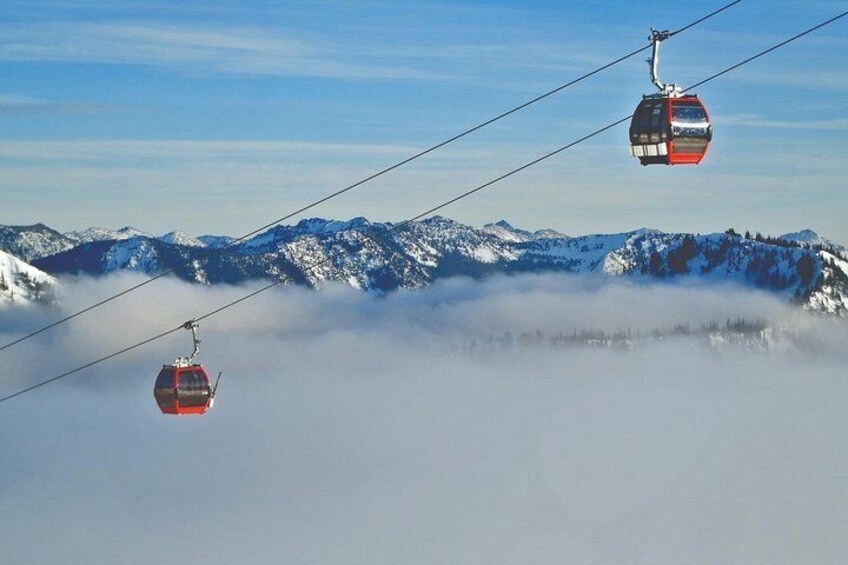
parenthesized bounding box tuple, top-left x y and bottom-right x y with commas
(153, 321, 221, 414)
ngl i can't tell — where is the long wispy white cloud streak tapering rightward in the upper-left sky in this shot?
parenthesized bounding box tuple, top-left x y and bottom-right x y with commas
(0, 22, 458, 80)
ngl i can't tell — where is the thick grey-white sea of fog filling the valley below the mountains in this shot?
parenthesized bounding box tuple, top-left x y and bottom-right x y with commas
(0, 275, 848, 565)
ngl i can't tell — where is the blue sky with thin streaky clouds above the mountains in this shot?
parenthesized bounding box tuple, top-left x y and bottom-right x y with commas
(0, 0, 848, 243)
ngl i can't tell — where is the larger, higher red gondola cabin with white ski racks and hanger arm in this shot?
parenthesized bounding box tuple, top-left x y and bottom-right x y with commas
(630, 30, 713, 165)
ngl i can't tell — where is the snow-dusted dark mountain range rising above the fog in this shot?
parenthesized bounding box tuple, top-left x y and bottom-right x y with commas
(0, 216, 848, 315)
